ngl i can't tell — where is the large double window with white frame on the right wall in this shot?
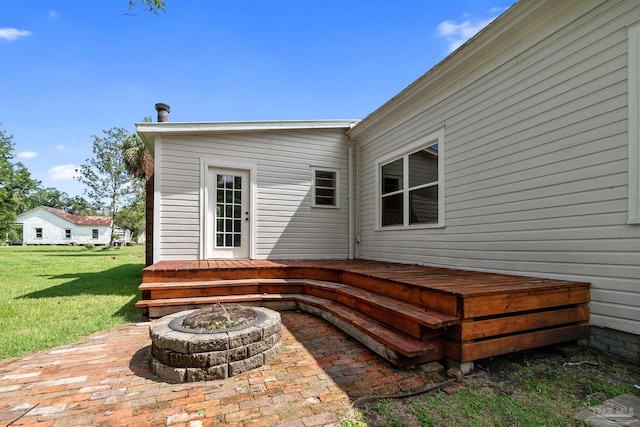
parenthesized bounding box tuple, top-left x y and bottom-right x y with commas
(376, 131, 444, 228)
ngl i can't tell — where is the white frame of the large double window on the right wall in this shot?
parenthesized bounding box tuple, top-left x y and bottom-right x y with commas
(375, 128, 445, 231)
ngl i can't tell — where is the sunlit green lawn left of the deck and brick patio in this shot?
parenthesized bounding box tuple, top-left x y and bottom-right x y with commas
(0, 246, 144, 360)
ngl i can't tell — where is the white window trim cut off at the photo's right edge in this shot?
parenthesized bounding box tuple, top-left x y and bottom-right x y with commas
(627, 21, 640, 224)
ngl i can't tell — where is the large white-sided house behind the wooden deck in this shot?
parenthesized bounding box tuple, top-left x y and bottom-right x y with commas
(136, 0, 640, 360)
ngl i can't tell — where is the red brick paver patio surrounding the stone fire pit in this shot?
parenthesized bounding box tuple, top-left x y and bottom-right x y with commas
(0, 312, 440, 427)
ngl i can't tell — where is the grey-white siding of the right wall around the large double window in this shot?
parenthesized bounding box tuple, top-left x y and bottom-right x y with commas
(352, 1, 640, 334)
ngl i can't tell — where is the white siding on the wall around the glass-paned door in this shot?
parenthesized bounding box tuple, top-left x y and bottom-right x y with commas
(155, 129, 351, 261)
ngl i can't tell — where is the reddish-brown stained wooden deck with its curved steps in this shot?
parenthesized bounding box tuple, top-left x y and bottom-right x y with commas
(136, 260, 589, 365)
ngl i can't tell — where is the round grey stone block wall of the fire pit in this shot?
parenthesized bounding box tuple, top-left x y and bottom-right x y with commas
(149, 307, 282, 383)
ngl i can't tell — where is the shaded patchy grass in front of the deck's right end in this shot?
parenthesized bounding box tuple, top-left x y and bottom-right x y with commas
(340, 345, 640, 427)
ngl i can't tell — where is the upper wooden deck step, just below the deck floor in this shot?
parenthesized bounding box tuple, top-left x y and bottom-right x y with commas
(140, 279, 460, 338)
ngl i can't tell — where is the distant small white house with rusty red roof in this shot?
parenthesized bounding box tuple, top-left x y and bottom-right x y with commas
(17, 206, 111, 245)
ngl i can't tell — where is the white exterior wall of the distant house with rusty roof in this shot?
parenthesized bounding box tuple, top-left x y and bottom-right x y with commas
(18, 209, 111, 245)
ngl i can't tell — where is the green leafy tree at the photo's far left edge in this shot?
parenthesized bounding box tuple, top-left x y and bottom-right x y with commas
(0, 129, 39, 244)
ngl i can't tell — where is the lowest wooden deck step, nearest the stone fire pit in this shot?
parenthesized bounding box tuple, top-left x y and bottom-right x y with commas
(136, 293, 444, 366)
